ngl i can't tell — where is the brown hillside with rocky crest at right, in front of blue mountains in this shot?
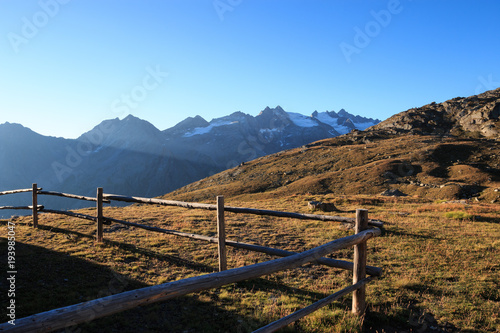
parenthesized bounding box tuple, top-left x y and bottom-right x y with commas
(167, 88, 500, 203)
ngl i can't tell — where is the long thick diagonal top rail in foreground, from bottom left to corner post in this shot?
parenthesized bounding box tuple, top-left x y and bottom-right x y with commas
(0, 229, 381, 332)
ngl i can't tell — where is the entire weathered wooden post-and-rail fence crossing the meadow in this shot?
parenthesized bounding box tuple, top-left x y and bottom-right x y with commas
(0, 184, 383, 332)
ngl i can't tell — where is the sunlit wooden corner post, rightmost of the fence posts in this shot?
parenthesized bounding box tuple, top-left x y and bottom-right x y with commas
(352, 209, 368, 316)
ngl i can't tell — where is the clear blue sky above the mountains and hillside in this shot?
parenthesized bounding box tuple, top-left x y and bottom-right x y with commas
(0, 0, 500, 138)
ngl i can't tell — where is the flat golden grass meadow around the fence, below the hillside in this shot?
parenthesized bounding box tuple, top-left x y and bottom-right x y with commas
(0, 192, 500, 332)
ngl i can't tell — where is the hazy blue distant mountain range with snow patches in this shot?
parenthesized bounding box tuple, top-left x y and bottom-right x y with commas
(0, 106, 380, 215)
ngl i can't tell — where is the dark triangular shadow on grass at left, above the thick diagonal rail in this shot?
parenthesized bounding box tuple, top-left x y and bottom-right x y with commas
(0, 238, 141, 324)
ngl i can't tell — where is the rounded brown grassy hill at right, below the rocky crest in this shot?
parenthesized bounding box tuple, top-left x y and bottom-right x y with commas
(169, 132, 500, 202)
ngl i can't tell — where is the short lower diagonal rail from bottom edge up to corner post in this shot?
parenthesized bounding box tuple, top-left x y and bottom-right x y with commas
(252, 277, 373, 333)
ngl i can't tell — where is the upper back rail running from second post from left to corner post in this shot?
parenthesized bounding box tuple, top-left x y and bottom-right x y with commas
(104, 194, 384, 227)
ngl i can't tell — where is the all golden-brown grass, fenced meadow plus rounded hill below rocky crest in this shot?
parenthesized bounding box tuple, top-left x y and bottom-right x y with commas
(0, 132, 500, 332)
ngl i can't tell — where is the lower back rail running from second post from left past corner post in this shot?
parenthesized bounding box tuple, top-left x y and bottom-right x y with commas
(104, 217, 382, 276)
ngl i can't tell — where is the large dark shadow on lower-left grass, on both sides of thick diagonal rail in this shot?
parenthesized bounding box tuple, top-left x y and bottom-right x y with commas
(0, 238, 274, 332)
